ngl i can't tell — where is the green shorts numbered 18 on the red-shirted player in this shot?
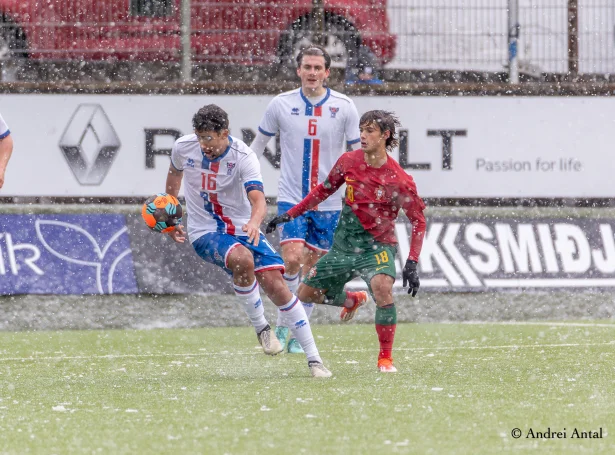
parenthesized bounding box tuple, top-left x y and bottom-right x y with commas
(303, 243, 397, 297)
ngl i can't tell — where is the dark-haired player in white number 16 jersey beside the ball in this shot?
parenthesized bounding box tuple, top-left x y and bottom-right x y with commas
(166, 104, 331, 377)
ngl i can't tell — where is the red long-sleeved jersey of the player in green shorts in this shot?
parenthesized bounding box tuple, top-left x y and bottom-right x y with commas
(288, 150, 425, 261)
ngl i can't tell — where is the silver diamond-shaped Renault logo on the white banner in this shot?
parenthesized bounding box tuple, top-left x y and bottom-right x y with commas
(59, 104, 121, 185)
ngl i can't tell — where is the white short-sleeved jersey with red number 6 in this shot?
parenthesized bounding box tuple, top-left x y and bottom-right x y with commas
(259, 88, 360, 211)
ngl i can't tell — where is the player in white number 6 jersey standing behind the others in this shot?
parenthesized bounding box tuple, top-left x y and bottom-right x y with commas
(251, 45, 367, 353)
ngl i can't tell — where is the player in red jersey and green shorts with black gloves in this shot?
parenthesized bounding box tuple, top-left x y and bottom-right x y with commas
(267, 110, 425, 373)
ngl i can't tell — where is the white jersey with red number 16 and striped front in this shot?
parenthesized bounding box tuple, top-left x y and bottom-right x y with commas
(171, 134, 263, 243)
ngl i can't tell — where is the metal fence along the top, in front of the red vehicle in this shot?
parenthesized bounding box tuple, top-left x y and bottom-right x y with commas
(0, 0, 615, 82)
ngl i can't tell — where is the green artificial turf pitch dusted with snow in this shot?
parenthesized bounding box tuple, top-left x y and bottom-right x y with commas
(0, 322, 615, 454)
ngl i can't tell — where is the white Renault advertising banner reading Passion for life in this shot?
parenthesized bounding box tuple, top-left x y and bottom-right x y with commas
(0, 95, 615, 198)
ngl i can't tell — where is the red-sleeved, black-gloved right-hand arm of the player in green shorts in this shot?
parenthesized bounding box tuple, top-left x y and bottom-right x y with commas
(401, 180, 426, 297)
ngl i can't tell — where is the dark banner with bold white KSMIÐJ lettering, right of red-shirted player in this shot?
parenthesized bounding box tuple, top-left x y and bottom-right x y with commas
(396, 217, 615, 291)
